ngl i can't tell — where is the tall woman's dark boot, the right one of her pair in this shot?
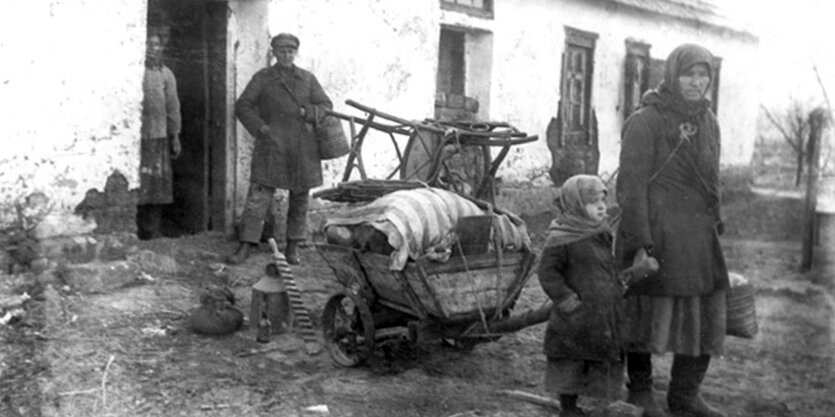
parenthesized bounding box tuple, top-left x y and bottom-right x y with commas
(667, 355, 726, 417)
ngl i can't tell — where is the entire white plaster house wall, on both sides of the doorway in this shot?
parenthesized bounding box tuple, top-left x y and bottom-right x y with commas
(0, 0, 757, 228)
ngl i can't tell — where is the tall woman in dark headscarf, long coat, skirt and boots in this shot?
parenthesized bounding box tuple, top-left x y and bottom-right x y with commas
(616, 44, 729, 417)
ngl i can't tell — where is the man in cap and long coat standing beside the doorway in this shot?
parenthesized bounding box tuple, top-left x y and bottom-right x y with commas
(226, 33, 333, 265)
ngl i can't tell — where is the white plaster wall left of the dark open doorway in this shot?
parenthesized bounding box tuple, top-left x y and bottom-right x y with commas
(0, 0, 146, 228)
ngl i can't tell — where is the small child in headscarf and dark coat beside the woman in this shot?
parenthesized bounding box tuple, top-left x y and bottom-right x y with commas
(539, 175, 623, 416)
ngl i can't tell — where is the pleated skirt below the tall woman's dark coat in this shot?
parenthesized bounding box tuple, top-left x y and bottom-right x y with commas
(625, 290, 727, 356)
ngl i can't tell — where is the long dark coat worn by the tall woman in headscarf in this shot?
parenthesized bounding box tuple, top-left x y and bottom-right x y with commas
(617, 85, 729, 296)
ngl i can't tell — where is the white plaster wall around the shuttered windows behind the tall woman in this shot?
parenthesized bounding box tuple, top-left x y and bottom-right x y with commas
(491, 0, 759, 181)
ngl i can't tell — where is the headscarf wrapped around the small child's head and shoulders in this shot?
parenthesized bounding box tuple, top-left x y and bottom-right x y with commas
(545, 175, 610, 248)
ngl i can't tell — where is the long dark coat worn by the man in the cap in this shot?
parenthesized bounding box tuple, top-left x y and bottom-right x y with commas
(235, 66, 333, 191)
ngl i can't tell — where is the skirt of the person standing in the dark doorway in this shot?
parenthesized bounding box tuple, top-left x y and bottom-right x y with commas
(138, 138, 174, 205)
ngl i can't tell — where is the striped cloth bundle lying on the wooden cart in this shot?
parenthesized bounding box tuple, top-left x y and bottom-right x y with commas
(325, 187, 530, 271)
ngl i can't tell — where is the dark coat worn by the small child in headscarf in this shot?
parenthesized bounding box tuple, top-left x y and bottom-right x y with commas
(538, 233, 623, 361)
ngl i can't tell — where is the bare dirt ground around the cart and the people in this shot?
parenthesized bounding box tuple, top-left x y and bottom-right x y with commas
(0, 183, 835, 417)
